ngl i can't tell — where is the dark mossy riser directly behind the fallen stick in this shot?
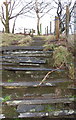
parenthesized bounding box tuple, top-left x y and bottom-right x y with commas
(2, 69, 69, 82)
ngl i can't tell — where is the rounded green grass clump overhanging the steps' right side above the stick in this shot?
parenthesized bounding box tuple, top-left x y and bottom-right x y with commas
(53, 46, 74, 79)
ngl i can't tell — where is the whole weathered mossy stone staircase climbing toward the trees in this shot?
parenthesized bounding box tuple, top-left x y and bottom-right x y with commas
(0, 37, 76, 119)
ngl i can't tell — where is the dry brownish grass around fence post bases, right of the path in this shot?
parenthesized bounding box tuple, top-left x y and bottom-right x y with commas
(44, 34, 75, 52)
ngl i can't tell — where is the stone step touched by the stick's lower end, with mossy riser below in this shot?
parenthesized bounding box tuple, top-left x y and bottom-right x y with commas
(0, 82, 75, 100)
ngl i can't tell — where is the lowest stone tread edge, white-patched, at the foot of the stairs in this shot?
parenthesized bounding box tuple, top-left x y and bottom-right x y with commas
(18, 110, 76, 120)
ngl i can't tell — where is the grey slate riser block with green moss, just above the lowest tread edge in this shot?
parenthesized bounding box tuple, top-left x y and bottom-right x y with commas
(17, 104, 74, 113)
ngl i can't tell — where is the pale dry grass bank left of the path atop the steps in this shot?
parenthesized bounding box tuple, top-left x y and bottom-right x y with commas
(0, 33, 32, 47)
